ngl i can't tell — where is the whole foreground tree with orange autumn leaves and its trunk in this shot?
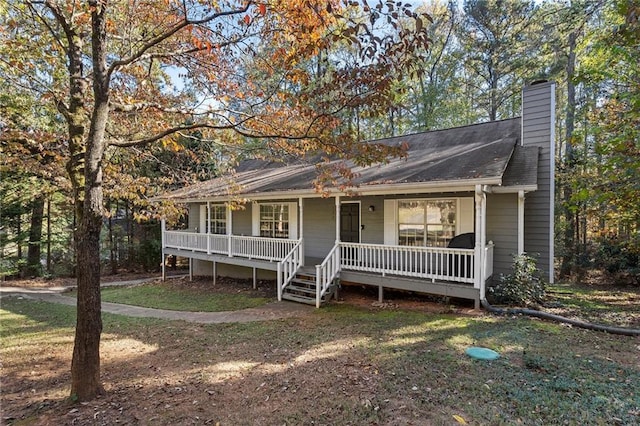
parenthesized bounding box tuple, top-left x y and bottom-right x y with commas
(0, 0, 429, 400)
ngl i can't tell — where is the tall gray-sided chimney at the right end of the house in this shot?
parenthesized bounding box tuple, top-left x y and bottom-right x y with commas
(522, 82, 555, 280)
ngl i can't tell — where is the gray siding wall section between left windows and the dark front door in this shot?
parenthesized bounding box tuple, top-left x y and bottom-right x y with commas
(302, 198, 336, 259)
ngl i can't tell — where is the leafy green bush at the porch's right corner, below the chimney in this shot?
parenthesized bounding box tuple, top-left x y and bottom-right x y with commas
(489, 254, 546, 306)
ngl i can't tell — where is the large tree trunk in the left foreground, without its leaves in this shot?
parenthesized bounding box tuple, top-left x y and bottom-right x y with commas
(71, 2, 109, 401)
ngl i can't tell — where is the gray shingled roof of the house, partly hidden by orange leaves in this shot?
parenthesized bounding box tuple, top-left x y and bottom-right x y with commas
(160, 118, 538, 201)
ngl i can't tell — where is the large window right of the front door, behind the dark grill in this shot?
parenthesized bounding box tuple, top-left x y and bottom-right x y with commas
(398, 199, 457, 247)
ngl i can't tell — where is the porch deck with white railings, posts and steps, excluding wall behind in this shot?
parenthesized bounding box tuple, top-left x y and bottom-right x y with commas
(162, 197, 494, 307)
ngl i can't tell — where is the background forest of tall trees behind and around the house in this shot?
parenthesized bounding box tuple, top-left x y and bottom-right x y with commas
(0, 0, 640, 283)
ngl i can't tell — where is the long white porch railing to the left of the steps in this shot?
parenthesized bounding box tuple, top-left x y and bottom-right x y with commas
(164, 231, 300, 261)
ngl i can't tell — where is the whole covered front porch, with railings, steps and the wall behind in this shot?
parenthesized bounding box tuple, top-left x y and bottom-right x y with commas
(162, 185, 512, 307)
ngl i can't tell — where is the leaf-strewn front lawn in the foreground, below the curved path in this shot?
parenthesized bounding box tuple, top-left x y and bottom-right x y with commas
(0, 289, 640, 425)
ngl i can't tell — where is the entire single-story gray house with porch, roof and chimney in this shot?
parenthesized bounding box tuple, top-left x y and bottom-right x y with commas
(156, 82, 555, 307)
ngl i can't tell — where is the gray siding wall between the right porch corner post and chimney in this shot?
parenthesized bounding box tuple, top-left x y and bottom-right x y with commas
(487, 194, 518, 280)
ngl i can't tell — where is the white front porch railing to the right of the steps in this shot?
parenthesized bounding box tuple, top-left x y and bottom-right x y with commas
(339, 242, 475, 283)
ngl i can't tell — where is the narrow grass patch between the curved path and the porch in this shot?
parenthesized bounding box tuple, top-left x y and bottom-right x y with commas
(71, 284, 270, 312)
